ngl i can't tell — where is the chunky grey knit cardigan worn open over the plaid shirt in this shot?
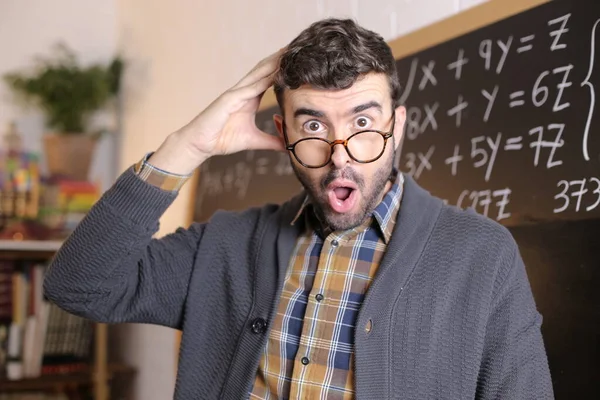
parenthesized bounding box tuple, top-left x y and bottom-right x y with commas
(44, 169, 553, 400)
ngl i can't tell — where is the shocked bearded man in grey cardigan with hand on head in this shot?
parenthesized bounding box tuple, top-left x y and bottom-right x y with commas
(44, 19, 553, 399)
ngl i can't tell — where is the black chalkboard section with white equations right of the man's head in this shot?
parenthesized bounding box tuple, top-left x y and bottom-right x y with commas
(398, 1, 600, 226)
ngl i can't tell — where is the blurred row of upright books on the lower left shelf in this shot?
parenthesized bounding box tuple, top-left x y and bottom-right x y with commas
(0, 260, 93, 382)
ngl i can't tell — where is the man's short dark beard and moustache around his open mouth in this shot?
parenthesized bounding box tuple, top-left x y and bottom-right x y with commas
(292, 152, 394, 231)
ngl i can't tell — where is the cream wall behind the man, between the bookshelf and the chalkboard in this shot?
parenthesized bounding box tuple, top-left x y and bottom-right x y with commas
(117, 0, 483, 400)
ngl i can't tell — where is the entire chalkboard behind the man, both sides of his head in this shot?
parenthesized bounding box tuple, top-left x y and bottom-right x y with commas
(194, 0, 600, 399)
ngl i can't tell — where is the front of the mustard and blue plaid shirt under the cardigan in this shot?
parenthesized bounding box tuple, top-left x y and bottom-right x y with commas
(249, 173, 404, 400)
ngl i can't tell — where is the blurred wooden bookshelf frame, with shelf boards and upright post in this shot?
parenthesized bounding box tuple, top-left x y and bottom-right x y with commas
(0, 240, 135, 400)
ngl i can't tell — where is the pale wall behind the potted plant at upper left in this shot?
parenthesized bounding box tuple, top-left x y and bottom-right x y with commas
(0, 0, 118, 191)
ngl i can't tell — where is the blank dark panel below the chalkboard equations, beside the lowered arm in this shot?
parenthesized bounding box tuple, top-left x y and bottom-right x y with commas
(509, 219, 600, 400)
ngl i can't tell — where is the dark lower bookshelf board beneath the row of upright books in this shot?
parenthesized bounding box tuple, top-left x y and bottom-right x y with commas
(0, 364, 135, 394)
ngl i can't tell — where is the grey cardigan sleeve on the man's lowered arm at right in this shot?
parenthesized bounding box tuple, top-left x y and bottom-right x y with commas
(477, 242, 554, 400)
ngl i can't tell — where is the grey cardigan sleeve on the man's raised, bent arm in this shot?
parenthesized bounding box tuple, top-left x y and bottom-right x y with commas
(43, 168, 204, 328)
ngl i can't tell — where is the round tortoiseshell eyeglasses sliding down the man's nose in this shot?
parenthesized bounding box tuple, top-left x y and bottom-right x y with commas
(283, 113, 396, 168)
